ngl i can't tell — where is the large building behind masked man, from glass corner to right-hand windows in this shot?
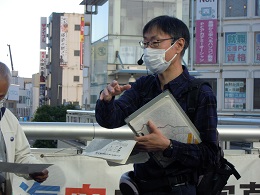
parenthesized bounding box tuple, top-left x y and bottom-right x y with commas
(83, 0, 260, 113)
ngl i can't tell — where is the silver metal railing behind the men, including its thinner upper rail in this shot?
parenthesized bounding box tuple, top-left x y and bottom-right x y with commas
(20, 110, 260, 149)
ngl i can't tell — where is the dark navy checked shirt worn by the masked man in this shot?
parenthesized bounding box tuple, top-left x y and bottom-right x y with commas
(95, 66, 218, 180)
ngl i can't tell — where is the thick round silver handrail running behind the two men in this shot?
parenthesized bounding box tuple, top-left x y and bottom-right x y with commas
(20, 121, 260, 142)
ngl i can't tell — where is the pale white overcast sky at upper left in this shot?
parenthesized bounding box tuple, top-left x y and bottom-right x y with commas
(0, 0, 84, 78)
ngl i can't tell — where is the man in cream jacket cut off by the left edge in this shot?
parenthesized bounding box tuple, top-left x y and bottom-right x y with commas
(0, 62, 49, 195)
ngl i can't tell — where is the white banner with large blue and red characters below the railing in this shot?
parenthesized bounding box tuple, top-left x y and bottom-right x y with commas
(13, 153, 260, 195)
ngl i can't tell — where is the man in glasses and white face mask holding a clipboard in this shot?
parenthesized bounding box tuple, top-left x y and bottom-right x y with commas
(95, 15, 218, 195)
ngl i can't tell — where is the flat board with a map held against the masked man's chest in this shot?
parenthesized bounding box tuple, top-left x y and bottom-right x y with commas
(125, 90, 201, 167)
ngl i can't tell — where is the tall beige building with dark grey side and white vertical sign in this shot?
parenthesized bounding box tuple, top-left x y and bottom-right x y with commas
(45, 13, 84, 107)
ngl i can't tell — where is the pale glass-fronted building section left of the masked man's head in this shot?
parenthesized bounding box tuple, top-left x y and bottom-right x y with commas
(83, 0, 189, 109)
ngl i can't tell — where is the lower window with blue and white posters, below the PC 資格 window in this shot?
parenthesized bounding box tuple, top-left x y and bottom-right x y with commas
(224, 79, 246, 110)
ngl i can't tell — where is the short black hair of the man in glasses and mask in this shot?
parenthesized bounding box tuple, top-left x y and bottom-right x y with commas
(143, 15, 190, 56)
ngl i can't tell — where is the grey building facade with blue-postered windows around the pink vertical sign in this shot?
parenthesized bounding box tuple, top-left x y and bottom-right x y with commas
(193, 0, 260, 113)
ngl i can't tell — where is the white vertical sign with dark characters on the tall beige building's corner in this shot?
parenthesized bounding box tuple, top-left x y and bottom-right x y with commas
(60, 16, 68, 66)
